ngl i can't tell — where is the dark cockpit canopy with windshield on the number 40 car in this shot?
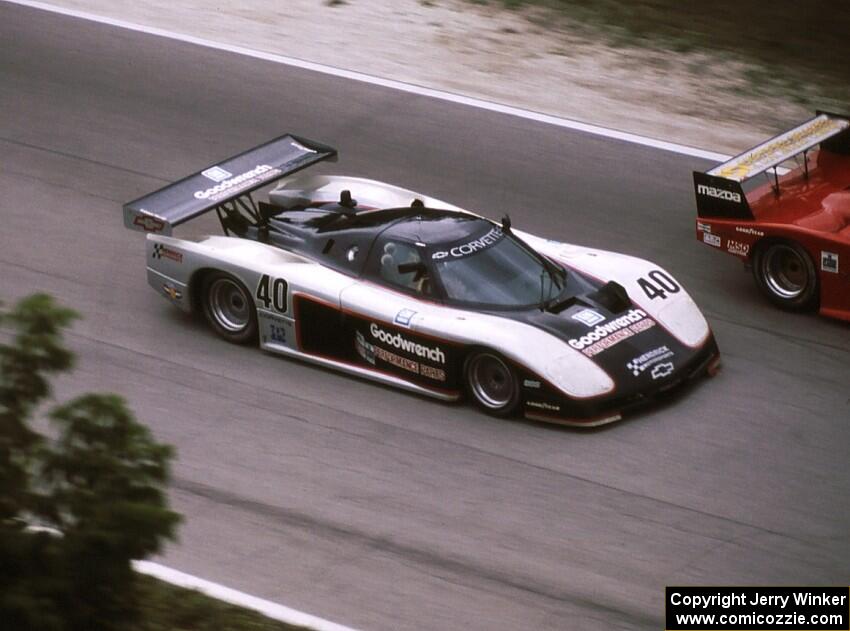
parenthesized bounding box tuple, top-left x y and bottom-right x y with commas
(262, 206, 566, 309)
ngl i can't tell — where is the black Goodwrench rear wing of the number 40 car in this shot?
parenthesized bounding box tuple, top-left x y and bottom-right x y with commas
(124, 134, 337, 234)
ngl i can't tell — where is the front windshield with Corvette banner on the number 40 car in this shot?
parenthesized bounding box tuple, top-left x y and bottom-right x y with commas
(431, 229, 564, 307)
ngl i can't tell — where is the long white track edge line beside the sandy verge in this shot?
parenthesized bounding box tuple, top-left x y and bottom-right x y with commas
(0, 0, 730, 162)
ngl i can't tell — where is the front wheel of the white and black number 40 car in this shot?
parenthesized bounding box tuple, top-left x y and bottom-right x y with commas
(464, 349, 522, 417)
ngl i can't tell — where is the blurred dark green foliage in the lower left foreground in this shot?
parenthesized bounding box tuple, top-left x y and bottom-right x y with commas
(0, 295, 179, 631)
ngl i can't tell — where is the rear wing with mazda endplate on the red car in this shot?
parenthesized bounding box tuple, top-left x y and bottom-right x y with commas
(694, 112, 850, 219)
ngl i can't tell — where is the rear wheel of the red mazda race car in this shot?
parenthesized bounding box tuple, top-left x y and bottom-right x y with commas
(753, 240, 818, 311)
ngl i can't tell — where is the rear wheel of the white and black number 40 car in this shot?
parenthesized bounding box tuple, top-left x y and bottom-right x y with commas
(200, 272, 258, 344)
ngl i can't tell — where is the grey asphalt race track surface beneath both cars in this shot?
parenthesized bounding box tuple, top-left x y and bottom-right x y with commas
(0, 3, 850, 631)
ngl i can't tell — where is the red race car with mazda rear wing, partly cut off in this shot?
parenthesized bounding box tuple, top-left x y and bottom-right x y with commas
(694, 112, 850, 321)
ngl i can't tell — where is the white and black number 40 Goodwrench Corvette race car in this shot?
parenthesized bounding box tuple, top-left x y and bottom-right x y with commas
(124, 135, 719, 426)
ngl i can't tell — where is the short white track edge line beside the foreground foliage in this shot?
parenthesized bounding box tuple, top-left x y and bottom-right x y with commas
(133, 561, 355, 631)
